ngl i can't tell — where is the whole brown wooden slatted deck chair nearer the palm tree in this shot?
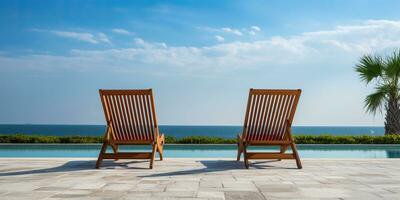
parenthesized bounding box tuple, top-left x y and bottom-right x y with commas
(237, 89, 302, 169)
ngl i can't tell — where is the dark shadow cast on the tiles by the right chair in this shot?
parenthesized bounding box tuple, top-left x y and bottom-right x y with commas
(140, 160, 297, 177)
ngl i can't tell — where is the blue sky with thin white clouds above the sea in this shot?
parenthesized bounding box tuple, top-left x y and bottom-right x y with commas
(0, 0, 400, 125)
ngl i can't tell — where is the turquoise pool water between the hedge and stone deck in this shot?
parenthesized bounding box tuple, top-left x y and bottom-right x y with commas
(0, 144, 400, 158)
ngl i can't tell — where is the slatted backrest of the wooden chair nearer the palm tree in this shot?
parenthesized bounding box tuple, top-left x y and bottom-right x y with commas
(243, 89, 301, 141)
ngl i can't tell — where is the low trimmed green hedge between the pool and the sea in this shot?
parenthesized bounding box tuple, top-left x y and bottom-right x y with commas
(0, 134, 400, 144)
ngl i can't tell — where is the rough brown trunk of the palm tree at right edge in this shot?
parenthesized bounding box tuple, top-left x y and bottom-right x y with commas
(385, 98, 400, 135)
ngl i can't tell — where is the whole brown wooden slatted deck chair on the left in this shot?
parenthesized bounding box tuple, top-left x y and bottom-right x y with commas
(96, 89, 164, 169)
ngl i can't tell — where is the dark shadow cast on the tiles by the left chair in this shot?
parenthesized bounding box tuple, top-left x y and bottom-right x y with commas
(0, 160, 149, 177)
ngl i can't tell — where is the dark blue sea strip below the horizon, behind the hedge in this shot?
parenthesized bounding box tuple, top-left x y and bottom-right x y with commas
(0, 124, 385, 138)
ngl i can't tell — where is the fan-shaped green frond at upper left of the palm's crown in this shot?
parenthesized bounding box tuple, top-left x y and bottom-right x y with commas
(355, 55, 384, 84)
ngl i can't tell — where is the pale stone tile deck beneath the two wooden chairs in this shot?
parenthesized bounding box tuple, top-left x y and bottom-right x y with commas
(0, 158, 400, 200)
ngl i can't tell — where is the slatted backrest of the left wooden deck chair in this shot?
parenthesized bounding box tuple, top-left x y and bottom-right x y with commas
(99, 89, 158, 141)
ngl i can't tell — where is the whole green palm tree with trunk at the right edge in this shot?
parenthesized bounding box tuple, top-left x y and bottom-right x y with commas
(355, 50, 400, 135)
